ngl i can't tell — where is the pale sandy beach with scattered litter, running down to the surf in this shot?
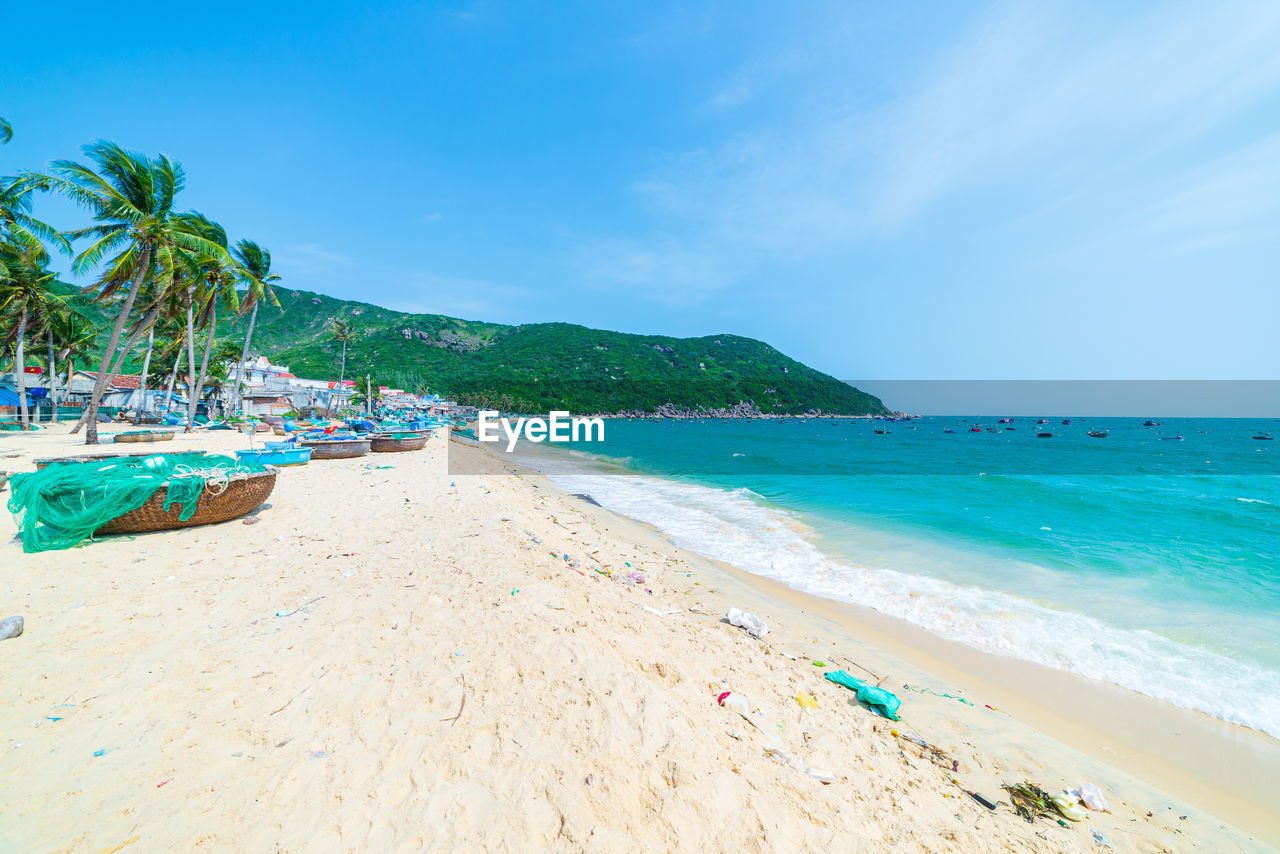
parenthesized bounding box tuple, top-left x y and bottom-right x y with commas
(0, 428, 1280, 854)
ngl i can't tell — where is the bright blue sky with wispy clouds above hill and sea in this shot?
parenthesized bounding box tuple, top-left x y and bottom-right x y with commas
(0, 0, 1280, 379)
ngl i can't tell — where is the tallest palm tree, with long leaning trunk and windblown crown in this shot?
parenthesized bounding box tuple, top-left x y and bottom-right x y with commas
(29, 141, 227, 444)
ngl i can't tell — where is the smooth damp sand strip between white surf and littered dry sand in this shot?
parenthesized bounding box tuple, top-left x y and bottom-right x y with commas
(470, 446, 1280, 846)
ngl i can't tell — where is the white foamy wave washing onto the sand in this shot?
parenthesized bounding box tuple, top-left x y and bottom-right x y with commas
(552, 472, 1280, 737)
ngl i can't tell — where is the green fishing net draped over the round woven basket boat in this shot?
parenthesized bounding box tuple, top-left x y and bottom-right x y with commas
(9, 453, 264, 552)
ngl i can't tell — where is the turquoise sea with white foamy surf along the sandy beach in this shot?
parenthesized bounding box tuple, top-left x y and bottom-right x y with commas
(522, 417, 1280, 736)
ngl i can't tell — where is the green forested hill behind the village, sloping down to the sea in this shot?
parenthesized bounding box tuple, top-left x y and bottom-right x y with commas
(72, 288, 887, 415)
